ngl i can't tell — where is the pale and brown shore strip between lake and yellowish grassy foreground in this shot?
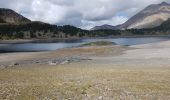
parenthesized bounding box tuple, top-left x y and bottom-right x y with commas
(0, 41, 170, 66)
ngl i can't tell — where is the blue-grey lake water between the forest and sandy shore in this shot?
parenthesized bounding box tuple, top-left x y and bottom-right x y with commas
(0, 37, 170, 53)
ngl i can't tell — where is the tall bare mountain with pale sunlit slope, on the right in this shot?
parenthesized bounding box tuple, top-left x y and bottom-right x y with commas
(93, 2, 170, 30)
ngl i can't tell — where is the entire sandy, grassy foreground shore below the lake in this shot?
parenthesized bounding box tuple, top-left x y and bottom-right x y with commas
(0, 41, 170, 100)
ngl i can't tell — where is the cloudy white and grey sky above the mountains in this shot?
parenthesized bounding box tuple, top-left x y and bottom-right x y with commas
(0, 0, 170, 29)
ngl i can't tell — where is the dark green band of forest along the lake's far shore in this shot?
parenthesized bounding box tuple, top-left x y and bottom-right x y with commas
(0, 20, 170, 39)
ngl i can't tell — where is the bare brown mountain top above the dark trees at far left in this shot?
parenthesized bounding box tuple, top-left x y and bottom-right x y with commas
(0, 8, 31, 24)
